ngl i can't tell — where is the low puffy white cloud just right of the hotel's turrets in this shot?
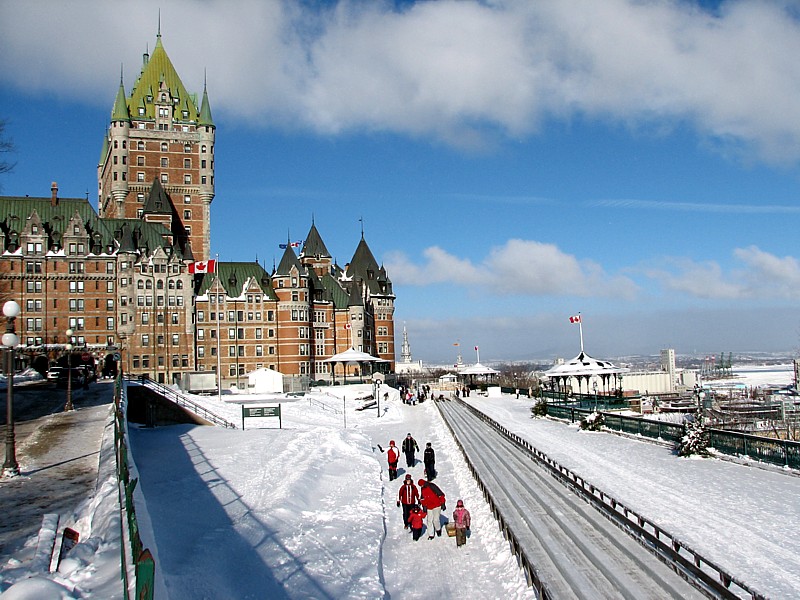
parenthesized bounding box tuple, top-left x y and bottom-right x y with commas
(386, 239, 637, 299)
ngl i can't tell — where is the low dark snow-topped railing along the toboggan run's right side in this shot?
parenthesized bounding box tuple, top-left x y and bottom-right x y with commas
(458, 399, 766, 600)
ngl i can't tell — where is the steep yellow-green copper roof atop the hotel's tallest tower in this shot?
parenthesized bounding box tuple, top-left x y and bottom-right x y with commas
(128, 35, 203, 122)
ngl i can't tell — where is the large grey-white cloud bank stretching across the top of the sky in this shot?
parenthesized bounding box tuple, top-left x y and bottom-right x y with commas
(0, 0, 800, 161)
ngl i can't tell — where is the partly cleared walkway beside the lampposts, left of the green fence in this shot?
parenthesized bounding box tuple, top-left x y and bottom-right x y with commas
(0, 382, 114, 568)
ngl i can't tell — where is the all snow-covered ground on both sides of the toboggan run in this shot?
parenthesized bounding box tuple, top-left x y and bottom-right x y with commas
(0, 368, 800, 600)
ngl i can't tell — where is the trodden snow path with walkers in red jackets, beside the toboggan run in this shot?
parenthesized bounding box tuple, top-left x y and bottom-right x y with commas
(361, 402, 534, 599)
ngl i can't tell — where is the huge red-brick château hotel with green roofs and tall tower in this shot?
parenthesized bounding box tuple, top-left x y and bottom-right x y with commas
(0, 33, 395, 387)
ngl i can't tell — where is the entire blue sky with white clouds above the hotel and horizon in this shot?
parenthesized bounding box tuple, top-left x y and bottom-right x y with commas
(0, 0, 800, 363)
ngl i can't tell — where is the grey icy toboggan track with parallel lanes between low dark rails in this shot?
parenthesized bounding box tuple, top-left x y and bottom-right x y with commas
(439, 402, 703, 599)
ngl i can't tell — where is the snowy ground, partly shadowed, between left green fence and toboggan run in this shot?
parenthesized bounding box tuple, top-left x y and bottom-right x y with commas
(131, 400, 534, 600)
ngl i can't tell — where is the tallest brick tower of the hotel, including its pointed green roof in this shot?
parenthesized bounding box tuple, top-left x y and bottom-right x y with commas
(97, 32, 216, 260)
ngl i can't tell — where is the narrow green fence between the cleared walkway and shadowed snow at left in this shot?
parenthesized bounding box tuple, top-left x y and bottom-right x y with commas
(114, 370, 156, 600)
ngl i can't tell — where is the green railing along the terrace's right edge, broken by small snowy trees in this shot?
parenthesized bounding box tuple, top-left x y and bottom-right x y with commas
(547, 403, 800, 469)
